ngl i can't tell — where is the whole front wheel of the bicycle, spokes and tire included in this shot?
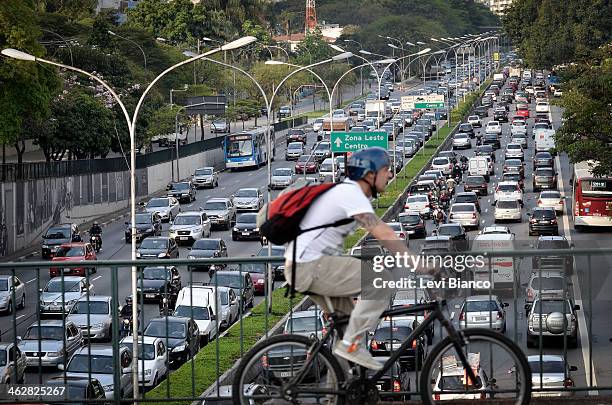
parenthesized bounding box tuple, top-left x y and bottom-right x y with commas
(420, 328, 531, 405)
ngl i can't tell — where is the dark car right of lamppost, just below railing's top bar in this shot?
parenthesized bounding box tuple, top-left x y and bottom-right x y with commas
(136, 266, 183, 302)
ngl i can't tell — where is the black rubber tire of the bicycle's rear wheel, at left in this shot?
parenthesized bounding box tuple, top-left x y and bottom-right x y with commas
(232, 335, 345, 405)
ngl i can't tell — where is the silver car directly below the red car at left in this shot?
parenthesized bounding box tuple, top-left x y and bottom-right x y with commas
(39, 276, 95, 316)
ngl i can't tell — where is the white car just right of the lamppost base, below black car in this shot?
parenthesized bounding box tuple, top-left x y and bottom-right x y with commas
(119, 336, 170, 387)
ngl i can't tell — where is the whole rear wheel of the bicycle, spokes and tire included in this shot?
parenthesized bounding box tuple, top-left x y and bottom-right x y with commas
(232, 335, 345, 405)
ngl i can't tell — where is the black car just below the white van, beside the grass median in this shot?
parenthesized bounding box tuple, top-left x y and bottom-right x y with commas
(144, 316, 200, 368)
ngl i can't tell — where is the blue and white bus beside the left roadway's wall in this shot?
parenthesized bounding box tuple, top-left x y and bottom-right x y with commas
(223, 127, 276, 169)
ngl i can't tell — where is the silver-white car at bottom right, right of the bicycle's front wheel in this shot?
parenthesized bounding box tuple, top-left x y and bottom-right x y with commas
(527, 354, 578, 397)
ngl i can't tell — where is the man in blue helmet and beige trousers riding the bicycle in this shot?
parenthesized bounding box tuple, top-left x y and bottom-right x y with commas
(285, 147, 424, 370)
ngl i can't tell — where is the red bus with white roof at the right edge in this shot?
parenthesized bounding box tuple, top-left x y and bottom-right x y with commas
(573, 161, 612, 230)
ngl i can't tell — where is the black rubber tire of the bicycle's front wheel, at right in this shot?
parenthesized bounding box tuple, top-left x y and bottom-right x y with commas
(419, 328, 532, 405)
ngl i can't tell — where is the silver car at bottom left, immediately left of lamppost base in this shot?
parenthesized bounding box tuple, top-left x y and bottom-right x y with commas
(58, 344, 133, 399)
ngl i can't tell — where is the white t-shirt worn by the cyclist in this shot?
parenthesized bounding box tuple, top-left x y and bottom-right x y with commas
(285, 179, 374, 263)
